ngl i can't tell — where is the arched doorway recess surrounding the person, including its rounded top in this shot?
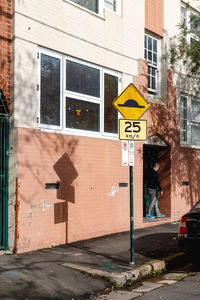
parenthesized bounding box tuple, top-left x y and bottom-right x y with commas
(143, 135, 171, 217)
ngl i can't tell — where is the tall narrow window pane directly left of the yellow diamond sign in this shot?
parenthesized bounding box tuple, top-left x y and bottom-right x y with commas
(104, 74, 118, 133)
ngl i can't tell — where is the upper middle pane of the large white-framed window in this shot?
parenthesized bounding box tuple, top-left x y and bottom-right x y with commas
(66, 60, 100, 97)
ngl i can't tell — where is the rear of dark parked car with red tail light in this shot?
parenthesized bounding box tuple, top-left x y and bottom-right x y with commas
(178, 200, 200, 258)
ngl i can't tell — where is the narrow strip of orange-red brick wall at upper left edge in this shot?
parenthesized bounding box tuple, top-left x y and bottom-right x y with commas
(0, 0, 12, 106)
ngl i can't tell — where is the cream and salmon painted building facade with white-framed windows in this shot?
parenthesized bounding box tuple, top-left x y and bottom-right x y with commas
(0, 0, 200, 253)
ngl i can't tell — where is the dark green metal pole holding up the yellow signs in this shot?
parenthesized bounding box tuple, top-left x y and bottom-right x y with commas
(129, 166, 135, 264)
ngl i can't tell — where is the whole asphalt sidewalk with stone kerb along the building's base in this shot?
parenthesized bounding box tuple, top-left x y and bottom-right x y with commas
(0, 223, 184, 300)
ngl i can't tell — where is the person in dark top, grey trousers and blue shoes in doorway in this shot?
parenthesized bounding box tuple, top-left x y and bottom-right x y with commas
(146, 162, 165, 218)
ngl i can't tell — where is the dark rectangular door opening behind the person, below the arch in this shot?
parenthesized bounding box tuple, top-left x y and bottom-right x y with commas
(143, 145, 171, 217)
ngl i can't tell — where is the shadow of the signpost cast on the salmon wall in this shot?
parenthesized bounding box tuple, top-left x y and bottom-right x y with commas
(53, 153, 78, 229)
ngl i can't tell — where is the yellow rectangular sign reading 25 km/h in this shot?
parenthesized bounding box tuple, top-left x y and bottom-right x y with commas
(119, 119, 147, 141)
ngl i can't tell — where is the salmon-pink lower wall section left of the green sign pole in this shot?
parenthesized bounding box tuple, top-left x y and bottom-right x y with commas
(17, 132, 133, 252)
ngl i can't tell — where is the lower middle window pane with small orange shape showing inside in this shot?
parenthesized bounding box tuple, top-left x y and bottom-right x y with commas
(66, 97, 100, 131)
